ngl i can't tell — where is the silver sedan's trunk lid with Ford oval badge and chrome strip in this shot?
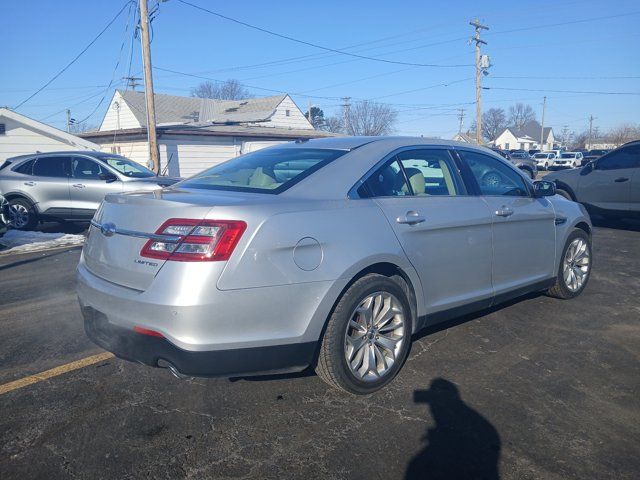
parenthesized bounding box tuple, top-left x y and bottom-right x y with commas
(83, 189, 245, 291)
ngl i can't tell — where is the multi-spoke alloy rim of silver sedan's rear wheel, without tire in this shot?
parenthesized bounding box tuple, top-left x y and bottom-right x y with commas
(344, 292, 406, 382)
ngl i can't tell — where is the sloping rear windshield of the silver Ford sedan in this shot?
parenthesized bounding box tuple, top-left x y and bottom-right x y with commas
(179, 148, 347, 194)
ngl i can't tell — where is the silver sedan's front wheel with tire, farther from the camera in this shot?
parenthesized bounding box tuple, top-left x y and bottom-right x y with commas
(547, 228, 592, 300)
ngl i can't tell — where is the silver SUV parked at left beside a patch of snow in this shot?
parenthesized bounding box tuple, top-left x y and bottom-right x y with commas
(0, 152, 178, 230)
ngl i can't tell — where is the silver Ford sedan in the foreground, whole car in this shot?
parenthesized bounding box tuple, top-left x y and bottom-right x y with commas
(78, 137, 592, 394)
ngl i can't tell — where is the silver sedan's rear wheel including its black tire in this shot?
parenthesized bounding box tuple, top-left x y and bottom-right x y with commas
(316, 274, 413, 395)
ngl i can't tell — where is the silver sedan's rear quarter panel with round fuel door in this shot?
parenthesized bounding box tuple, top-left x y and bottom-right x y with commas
(218, 199, 418, 290)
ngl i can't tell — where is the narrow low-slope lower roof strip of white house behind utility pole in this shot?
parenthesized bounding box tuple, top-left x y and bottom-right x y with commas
(81, 124, 339, 141)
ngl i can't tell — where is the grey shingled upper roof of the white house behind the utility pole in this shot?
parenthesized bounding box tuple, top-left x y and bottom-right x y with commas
(118, 90, 287, 126)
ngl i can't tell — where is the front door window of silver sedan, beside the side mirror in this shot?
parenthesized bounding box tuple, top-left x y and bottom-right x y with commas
(460, 151, 529, 197)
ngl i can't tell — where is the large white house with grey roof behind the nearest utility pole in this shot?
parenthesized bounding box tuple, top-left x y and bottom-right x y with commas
(82, 91, 333, 177)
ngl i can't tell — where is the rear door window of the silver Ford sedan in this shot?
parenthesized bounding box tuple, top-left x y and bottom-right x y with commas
(398, 149, 466, 195)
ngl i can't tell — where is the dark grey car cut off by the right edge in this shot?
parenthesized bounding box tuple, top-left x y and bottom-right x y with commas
(545, 140, 640, 217)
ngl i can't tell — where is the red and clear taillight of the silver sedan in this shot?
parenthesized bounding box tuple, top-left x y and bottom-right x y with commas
(140, 218, 247, 262)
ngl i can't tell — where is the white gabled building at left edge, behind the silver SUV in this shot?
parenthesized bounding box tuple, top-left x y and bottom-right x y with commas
(0, 108, 100, 162)
